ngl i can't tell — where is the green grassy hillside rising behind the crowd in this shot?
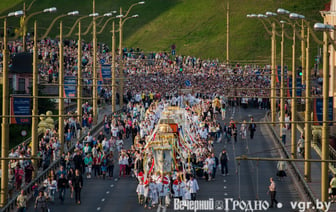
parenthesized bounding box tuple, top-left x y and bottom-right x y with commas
(0, 0, 329, 64)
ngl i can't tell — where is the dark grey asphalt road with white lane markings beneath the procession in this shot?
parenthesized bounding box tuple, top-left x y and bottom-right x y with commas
(28, 109, 299, 212)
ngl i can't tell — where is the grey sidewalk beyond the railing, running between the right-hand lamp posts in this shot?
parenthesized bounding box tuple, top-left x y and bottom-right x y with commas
(267, 112, 336, 211)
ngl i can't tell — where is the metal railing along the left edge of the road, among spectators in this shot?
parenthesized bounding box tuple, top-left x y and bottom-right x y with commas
(1, 110, 122, 212)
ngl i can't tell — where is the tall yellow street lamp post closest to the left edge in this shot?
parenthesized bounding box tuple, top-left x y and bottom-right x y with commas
(0, 11, 23, 207)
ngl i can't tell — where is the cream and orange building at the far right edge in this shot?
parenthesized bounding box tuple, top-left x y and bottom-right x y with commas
(321, 0, 336, 135)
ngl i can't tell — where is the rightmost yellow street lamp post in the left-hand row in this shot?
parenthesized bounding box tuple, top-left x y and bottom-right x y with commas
(119, 1, 145, 109)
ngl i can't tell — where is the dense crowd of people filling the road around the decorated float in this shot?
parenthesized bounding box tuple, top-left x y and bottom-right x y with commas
(1, 36, 318, 210)
